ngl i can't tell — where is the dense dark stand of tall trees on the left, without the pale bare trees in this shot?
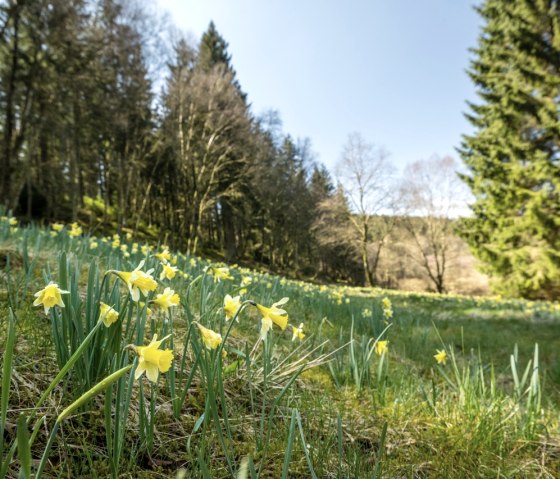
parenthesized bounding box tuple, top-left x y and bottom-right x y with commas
(0, 0, 368, 281)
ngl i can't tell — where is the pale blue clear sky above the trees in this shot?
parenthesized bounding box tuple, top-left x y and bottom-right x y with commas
(154, 0, 480, 175)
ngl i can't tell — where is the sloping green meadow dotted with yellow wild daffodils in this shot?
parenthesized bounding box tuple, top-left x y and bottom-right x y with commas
(0, 217, 560, 479)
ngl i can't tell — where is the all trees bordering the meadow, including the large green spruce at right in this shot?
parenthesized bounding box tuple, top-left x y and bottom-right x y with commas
(0, 0, 560, 299)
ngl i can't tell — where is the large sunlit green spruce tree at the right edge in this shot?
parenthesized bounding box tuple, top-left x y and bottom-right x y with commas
(460, 0, 560, 299)
